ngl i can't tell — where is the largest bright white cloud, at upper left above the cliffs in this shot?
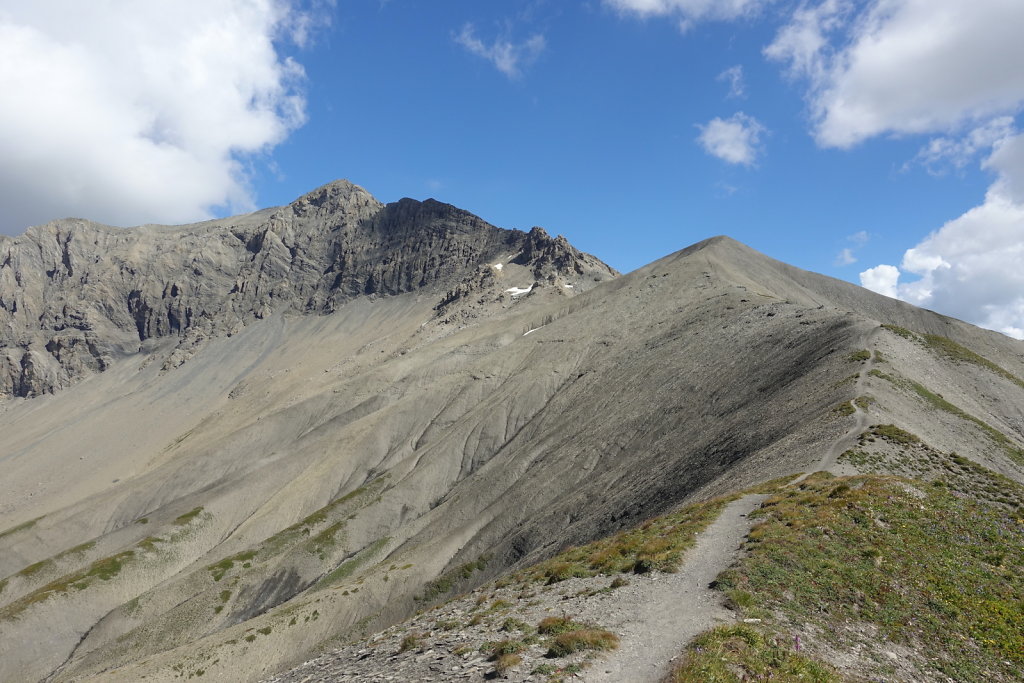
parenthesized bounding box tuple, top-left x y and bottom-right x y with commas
(0, 0, 308, 232)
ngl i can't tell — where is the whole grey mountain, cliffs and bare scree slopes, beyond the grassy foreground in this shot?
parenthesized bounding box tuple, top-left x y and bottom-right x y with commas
(0, 181, 1024, 681)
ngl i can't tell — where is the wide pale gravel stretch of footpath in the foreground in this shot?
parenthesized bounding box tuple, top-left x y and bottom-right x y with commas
(583, 496, 766, 683)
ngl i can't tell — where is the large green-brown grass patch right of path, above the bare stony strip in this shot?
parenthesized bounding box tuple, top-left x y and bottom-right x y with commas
(717, 476, 1024, 681)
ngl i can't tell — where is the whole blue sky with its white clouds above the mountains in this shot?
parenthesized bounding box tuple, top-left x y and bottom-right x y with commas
(0, 0, 1024, 337)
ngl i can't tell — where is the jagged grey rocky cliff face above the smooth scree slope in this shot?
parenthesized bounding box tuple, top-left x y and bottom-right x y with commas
(0, 180, 614, 396)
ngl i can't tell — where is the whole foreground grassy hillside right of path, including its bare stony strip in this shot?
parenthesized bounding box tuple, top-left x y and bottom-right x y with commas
(676, 473, 1024, 682)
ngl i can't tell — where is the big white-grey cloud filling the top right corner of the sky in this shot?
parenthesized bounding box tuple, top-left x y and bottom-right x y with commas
(765, 0, 1024, 147)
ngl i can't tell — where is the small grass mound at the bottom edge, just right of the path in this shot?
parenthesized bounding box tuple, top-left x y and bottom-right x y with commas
(669, 624, 843, 683)
